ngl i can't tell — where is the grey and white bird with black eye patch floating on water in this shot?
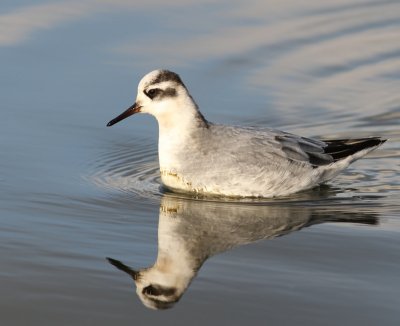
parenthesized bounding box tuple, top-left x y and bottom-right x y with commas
(107, 69, 387, 198)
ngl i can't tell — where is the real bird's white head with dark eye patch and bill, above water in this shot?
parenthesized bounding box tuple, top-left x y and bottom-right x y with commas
(107, 70, 205, 127)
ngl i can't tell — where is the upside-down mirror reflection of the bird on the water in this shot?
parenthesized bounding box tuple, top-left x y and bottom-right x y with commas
(107, 195, 378, 309)
